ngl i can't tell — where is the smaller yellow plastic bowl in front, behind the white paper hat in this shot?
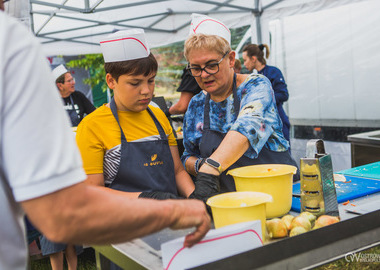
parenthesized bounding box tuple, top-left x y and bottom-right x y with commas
(207, 191, 272, 238)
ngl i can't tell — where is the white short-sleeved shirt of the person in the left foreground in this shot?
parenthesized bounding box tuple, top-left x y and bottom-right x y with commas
(0, 11, 86, 270)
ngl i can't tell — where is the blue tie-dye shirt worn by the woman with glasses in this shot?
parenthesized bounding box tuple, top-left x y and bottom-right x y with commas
(182, 74, 289, 163)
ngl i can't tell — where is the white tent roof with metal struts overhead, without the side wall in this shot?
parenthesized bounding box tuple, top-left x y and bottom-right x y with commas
(7, 0, 359, 55)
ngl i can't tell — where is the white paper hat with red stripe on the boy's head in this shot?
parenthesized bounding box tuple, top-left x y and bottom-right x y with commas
(100, 28, 150, 63)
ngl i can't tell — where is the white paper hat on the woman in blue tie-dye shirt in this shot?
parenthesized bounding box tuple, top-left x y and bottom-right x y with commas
(190, 13, 231, 44)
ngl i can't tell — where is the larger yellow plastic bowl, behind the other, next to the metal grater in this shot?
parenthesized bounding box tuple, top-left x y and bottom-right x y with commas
(227, 164, 297, 218)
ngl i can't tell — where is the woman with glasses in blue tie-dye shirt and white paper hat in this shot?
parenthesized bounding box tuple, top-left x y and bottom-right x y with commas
(182, 16, 296, 196)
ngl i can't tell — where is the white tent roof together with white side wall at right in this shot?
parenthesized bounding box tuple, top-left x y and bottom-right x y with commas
(6, 0, 380, 132)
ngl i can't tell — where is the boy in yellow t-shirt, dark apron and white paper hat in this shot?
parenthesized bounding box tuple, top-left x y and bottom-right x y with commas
(76, 29, 194, 199)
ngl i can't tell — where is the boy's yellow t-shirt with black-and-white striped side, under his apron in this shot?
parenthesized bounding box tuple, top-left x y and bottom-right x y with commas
(76, 104, 177, 185)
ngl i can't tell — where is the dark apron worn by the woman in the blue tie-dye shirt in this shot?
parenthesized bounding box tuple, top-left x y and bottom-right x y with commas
(199, 74, 297, 192)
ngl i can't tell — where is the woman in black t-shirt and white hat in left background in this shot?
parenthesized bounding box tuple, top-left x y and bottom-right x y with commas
(53, 65, 95, 127)
